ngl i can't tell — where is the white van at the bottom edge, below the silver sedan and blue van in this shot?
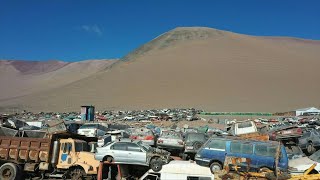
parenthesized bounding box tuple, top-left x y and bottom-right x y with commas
(139, 160, 214, 180)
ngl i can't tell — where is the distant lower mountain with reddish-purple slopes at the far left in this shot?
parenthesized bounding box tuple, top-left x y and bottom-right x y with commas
(0, 60, 115, 101)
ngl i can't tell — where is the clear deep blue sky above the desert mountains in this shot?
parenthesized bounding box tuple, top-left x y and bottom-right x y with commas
(0, 0, 320, 61)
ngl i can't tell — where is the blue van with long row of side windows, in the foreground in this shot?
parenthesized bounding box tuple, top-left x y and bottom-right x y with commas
(195, 137, 288, 173)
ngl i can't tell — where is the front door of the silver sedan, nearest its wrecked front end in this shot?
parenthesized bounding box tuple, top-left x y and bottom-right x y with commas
(128, 143, 147, 165)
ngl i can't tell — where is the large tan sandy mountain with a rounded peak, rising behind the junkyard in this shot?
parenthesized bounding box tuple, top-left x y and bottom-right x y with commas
(0, 27, 320, 112)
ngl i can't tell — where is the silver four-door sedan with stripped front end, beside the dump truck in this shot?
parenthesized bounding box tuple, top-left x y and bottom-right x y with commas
(95, 140, 171, 172)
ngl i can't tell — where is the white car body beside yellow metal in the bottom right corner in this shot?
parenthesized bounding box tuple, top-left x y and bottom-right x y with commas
(289, 150, 320, 174)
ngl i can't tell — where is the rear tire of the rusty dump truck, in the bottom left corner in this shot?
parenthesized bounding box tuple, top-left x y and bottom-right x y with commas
(0, 163, 21, 180)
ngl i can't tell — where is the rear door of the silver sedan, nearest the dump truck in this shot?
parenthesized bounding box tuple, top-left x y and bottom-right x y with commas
(110, 142, 128, 163)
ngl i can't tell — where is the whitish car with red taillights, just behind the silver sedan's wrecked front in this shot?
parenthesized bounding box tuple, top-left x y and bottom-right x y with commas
(157, 130, 184, 152)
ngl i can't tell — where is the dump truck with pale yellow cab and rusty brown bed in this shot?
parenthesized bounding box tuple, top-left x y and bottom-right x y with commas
(0, 133, 99, 180)
